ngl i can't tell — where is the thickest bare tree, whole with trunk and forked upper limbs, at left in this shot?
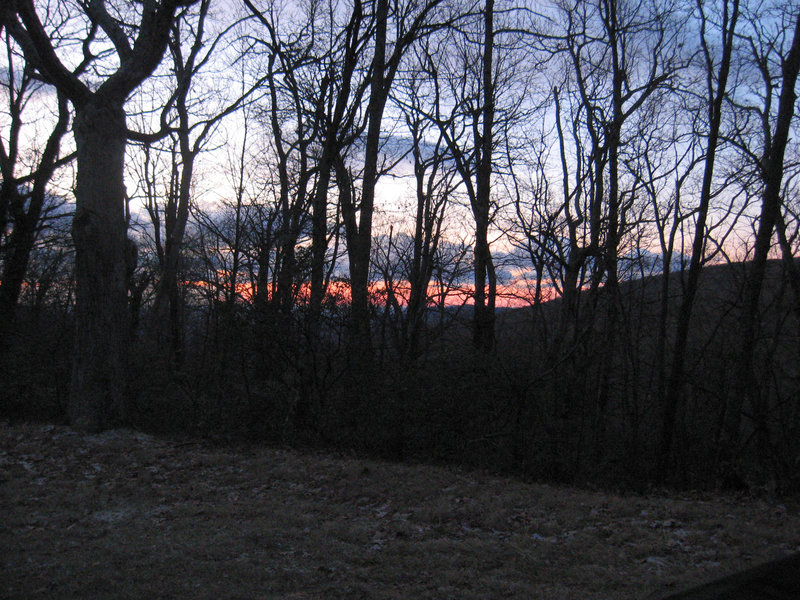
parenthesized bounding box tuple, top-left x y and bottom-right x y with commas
(0, 0, 199, 430)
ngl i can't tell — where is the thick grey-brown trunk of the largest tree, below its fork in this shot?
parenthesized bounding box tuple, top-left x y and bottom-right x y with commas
(68, 97, 130, 431)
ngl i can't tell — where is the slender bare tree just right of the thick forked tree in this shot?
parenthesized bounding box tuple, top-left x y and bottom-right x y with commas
(130, 0, 261, 368)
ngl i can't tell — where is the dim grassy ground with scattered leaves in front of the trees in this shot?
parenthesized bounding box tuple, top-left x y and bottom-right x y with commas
(0, 424, 800, 600)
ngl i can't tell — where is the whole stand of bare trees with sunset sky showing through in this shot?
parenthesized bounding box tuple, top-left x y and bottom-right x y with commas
(0, 0, 800, 493)
